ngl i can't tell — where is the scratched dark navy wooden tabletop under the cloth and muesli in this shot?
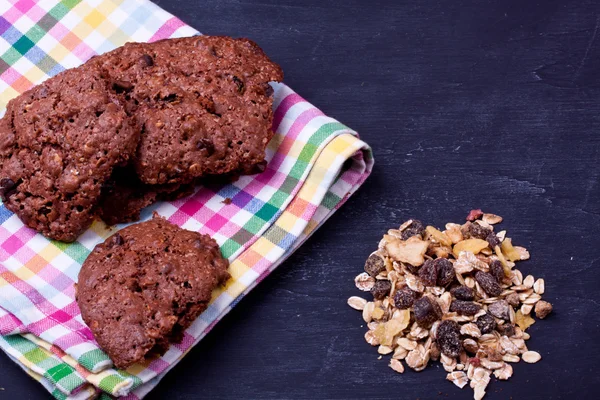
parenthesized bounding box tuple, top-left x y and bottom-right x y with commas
(0, 0, 600, 399)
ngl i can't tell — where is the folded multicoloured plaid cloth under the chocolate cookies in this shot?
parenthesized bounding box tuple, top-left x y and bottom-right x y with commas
(0, 0, 373, 399)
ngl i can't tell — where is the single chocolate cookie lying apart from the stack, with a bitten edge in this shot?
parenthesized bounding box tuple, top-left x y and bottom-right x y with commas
(76, 217, 229, 368)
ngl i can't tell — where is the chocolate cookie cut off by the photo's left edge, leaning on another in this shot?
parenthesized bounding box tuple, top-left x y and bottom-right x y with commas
(0, 66, 139, 242)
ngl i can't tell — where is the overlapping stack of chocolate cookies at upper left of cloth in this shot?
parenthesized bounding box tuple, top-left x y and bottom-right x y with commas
(0, 36, 283, 242)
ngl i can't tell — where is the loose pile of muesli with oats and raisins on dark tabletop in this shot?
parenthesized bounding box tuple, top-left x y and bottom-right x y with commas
(348, 210, 552, 399)
